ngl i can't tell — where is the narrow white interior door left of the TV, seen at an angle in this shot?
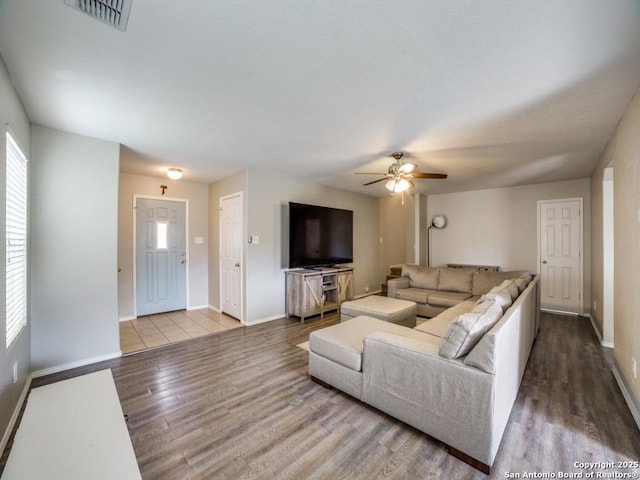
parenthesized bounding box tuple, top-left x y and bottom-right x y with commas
(220, 194, 243, 321)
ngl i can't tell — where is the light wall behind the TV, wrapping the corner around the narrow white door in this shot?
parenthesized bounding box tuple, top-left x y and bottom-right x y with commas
(209, 170, 380, 324)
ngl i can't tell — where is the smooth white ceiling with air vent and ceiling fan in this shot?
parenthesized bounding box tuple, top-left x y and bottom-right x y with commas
(0, 0, 640, 196)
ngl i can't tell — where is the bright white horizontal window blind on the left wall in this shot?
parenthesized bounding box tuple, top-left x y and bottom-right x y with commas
(5, 131, 27, 348)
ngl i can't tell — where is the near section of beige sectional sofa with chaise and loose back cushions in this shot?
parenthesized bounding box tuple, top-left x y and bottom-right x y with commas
(309, 275, 539, 473)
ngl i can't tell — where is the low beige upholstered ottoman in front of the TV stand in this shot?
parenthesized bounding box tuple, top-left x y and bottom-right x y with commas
(340, 295, 418, 328)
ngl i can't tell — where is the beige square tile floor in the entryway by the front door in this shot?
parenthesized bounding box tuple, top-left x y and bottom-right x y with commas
(120, 308, 242, 354)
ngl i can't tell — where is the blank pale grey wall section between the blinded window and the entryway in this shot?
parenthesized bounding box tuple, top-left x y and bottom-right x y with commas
(30, 126, 120, 371)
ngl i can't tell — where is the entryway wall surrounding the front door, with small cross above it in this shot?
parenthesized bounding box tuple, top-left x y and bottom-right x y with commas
(118, 173, 209, 320)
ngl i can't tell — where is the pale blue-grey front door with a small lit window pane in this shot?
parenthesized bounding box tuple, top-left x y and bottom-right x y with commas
(135, 198, 187, 316)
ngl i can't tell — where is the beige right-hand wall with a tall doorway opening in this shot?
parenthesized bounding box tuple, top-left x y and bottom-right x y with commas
(591, 87, 640, 426)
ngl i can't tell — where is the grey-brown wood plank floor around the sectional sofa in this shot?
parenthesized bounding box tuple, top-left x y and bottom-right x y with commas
(0, 314, 640, 480)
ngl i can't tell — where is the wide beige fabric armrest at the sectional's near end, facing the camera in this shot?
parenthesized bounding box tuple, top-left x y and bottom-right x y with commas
(362, 332, 500, 465)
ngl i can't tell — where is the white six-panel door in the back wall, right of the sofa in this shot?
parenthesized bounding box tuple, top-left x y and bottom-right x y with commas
(538, 199, 582, 313)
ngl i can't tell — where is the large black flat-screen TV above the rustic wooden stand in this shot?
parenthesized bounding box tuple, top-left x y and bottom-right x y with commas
(289, 202, 353, 268)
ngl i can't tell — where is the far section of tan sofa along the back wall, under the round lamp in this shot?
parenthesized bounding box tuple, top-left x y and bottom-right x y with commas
(387, 265, 527, 317)
